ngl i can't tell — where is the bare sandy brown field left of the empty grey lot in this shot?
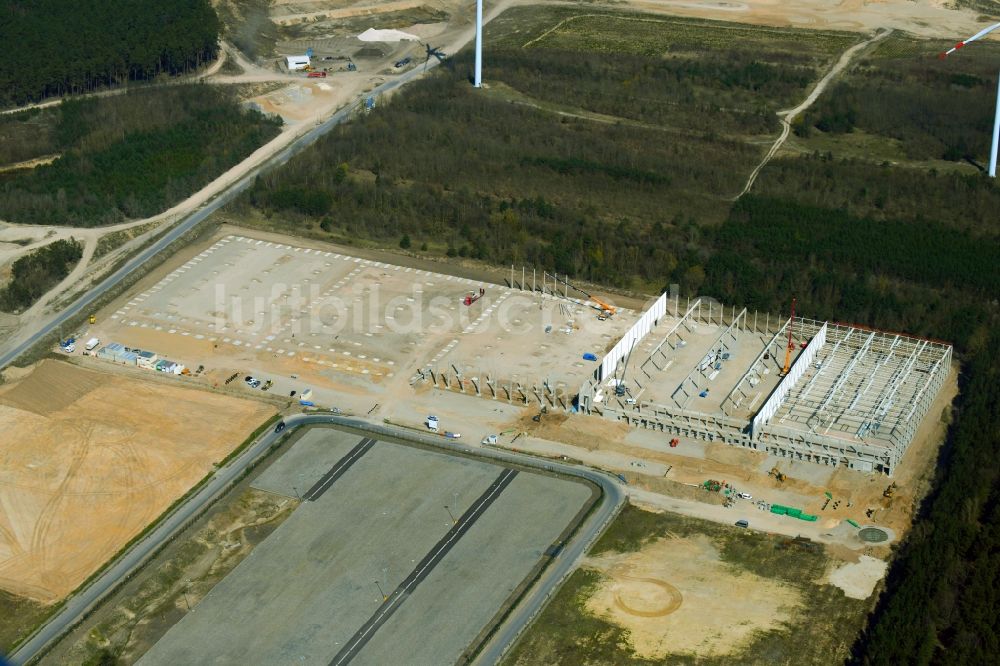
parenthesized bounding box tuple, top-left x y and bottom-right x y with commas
(0, 360, 274, 603)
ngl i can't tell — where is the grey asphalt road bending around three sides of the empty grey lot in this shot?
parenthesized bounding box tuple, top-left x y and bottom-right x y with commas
(10, 413, 627, 665)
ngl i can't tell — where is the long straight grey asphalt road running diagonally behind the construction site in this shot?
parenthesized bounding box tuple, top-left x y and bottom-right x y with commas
(0, 59, 438, 370)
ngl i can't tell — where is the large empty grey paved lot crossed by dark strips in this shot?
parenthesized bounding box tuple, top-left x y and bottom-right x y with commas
(142, 428, 592, 665)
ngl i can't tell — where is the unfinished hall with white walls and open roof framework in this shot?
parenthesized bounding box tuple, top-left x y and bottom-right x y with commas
(579, 295, 952, 474)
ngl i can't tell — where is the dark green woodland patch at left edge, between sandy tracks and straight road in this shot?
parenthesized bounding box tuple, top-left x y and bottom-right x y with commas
(0, 84, 281, 226)
